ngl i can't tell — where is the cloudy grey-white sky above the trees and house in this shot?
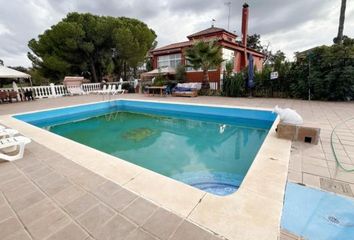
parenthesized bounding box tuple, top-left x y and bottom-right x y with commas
(0, 0, 354, 67)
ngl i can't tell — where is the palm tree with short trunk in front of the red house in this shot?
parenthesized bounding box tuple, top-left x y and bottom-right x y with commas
(186, 41, 224, 89)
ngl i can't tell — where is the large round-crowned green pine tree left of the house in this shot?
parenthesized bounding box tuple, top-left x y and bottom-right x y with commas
(28, 13, 156, 82)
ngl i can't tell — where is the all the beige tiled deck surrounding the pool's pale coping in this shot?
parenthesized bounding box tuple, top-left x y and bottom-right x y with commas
(0, 94, 354, 239)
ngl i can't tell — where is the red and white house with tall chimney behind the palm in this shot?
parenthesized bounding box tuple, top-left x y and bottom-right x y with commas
(150, 4, 264, 89)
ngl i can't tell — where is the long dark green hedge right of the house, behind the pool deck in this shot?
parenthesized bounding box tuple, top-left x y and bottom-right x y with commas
(223, 36, 354, 101)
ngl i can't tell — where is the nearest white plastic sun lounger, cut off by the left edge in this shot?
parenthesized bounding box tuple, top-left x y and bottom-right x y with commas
(0, 136, 31, 161)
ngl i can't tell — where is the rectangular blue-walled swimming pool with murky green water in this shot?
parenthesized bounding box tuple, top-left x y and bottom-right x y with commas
(15, 100, 276, 195)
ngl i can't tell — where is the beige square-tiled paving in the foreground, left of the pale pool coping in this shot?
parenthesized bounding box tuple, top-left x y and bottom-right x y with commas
(0, 142, 218, 240)
